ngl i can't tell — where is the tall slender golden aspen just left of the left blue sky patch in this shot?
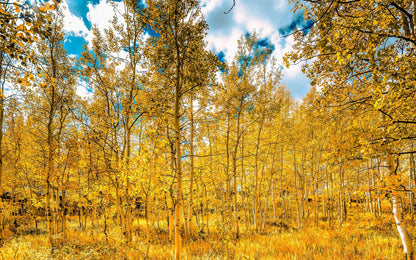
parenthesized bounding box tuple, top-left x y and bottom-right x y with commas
(21, 8, 76, 248)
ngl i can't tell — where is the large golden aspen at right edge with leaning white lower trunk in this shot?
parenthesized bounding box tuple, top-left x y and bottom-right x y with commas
(286, 0, 416, 258)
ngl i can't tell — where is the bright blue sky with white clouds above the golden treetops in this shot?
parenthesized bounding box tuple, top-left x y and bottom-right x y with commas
(63, 0, 309, 99)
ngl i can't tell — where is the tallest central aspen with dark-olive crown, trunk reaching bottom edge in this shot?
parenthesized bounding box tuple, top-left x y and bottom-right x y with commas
(143, 0, 214, 259)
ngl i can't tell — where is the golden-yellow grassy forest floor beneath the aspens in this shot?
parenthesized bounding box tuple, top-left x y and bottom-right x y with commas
(0, 209, 416, 260)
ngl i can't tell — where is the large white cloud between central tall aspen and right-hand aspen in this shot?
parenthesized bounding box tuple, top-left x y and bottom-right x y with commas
(203, 0, 309, 98)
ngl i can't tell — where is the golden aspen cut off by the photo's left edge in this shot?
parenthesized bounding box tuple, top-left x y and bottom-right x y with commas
(0, 0, 56, 243)
